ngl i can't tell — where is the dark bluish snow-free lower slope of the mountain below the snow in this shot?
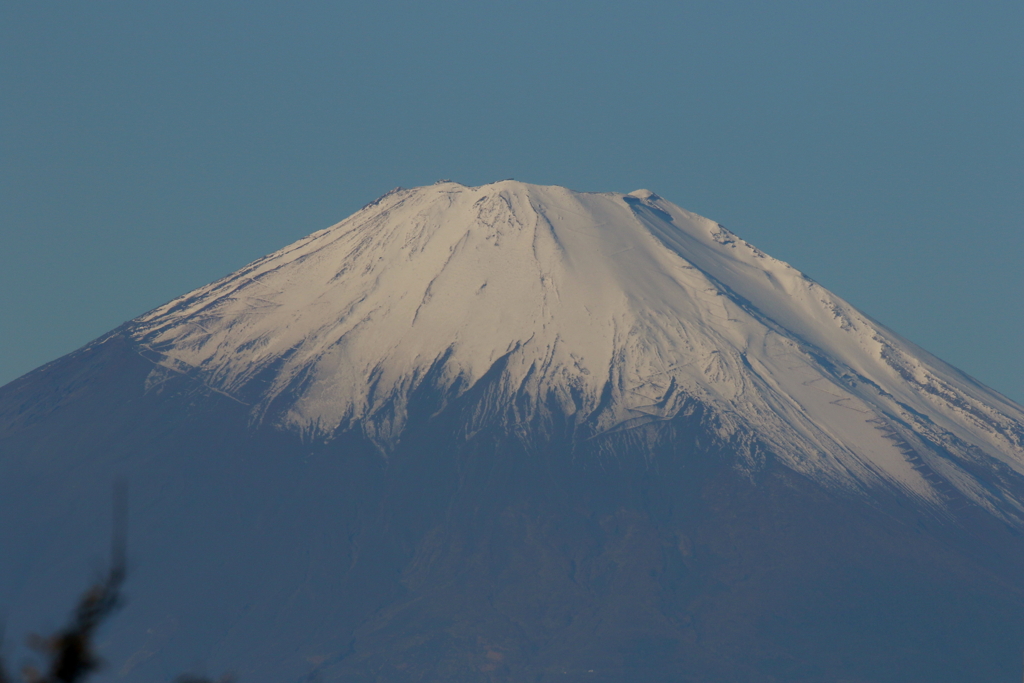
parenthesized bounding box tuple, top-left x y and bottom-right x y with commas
(0, 336, 1024, 683)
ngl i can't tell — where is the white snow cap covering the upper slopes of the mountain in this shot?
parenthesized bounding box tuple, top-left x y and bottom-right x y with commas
(129, 180, 1024, 519)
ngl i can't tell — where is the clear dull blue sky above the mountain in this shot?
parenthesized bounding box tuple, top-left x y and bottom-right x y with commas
(0, 0, 1024, 402)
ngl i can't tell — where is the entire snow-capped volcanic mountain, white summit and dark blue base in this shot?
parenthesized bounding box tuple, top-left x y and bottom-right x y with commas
(0, 180, 1024, 683)
